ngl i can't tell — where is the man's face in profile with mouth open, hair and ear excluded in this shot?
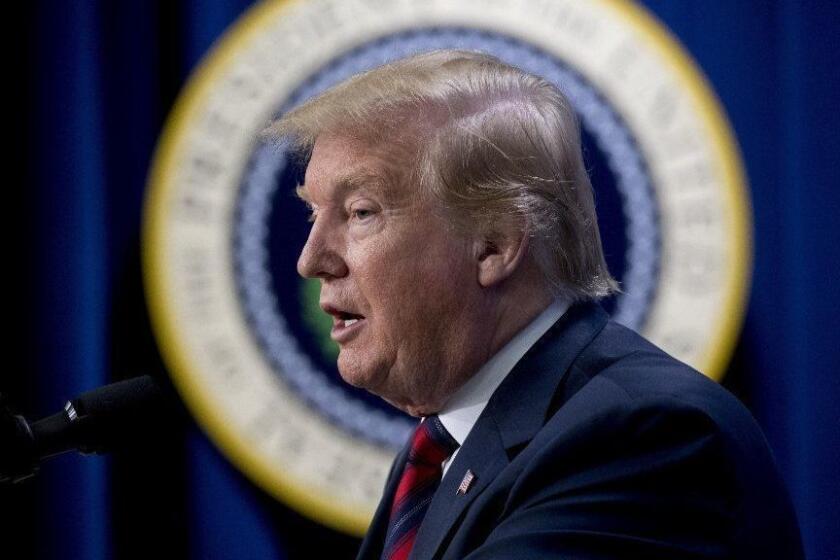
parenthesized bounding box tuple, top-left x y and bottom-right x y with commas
(298, 136, 488, 415)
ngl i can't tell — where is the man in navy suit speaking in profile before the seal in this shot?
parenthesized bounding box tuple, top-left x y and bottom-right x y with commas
(271, 51, 802, 560)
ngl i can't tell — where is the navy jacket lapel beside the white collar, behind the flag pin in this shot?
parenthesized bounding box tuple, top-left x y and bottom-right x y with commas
(406, 304, 608, 559)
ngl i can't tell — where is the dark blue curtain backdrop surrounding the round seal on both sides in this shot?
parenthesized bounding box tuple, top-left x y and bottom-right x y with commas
(0, 0, 840, 559)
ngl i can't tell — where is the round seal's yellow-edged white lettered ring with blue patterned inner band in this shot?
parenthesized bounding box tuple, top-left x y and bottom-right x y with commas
(143, 0, 751, 534)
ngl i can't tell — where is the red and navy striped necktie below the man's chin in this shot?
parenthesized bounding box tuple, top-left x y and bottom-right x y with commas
(382, 416, 458, 560)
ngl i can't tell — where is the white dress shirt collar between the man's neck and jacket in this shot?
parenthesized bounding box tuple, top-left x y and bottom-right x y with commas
(438, 299, 569, 474)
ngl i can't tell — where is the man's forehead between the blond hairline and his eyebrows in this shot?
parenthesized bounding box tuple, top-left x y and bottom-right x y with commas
(298, 136, 410, 202)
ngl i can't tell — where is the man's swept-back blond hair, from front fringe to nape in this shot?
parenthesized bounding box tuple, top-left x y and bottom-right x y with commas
(266, 50, 618, 301)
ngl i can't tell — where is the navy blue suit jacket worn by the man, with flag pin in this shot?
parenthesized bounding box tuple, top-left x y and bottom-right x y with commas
(358, 304, 802, 560)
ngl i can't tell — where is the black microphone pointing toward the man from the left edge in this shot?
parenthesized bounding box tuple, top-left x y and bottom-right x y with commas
(0, 375, 165, 482)
